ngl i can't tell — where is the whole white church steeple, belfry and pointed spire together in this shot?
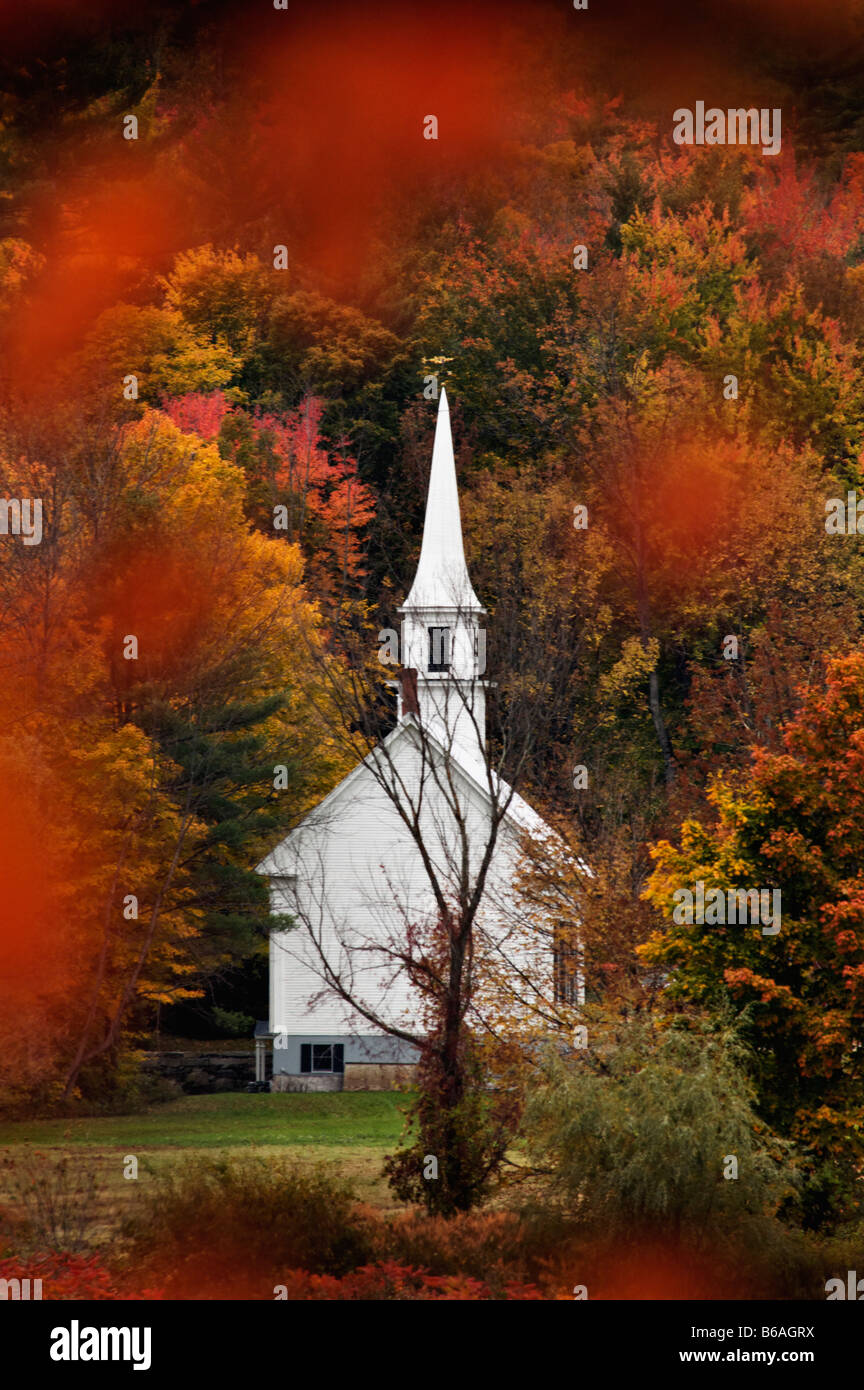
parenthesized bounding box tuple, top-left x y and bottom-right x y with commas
(399, 389, 486, 759)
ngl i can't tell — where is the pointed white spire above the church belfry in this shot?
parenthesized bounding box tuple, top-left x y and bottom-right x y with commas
(401, 386, 485, 613)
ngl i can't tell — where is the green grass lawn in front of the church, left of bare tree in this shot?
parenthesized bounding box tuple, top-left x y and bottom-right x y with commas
(0, 1091, 407, 1241)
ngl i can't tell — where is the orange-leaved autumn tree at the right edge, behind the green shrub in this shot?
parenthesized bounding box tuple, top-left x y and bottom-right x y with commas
(643, 648, 864, 1225)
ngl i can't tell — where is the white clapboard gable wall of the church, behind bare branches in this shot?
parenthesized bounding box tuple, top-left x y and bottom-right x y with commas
(261, 720, 547, 1034)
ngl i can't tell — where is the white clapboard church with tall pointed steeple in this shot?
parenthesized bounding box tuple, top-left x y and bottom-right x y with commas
(256, 391, 581, 1090)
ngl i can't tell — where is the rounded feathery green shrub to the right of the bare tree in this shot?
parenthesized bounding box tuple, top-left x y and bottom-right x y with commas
(524, 1022, 796, 1241)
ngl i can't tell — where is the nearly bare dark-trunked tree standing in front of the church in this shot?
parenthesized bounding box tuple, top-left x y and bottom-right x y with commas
(276, 581, 586, 1211)
